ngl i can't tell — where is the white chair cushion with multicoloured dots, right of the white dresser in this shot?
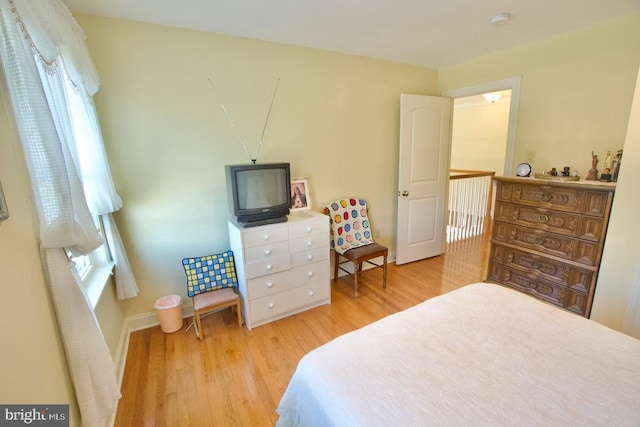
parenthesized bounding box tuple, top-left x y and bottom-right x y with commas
(323, 198, 375, 254)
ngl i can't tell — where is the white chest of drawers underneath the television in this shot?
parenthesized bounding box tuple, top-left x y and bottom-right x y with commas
(229, 211, 331, 330)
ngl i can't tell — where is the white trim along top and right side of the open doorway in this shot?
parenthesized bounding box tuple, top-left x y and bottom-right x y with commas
(442, 76, 522, 175)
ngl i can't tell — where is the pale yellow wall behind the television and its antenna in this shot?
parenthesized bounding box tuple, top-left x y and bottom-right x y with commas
(78, 15, 437, 316)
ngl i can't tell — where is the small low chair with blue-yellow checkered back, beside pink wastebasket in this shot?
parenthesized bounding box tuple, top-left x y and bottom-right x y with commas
(182, 251, 243, 339)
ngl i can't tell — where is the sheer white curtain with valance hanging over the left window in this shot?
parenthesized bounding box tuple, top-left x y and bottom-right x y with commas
(0, 0, 137, 426)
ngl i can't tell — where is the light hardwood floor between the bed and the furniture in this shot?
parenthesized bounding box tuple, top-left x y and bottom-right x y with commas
(115, 234, 489, 427)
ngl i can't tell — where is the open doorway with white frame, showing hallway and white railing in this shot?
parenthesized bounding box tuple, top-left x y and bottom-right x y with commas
(444, 77, 520, 243)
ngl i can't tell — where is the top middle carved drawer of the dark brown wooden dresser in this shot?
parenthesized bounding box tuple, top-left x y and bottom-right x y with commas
(512, 184, 585, 213)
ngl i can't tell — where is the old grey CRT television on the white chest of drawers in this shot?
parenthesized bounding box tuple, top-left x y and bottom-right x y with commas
(225, 163, 291, 227)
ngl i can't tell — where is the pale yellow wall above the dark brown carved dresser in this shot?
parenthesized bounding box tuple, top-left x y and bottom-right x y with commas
(438, 13, 640, 177)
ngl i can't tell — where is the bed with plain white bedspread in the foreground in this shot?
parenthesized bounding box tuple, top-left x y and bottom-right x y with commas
(277, 283, 640, 427)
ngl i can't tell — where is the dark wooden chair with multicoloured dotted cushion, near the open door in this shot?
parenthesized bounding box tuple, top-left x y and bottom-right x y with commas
(323, 198, 389, 298)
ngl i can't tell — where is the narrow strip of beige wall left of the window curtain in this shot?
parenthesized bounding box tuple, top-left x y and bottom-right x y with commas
(0, 72, 80, 426)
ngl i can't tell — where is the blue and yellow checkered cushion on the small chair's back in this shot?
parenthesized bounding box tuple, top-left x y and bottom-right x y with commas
(182, 251, 238, 297)
